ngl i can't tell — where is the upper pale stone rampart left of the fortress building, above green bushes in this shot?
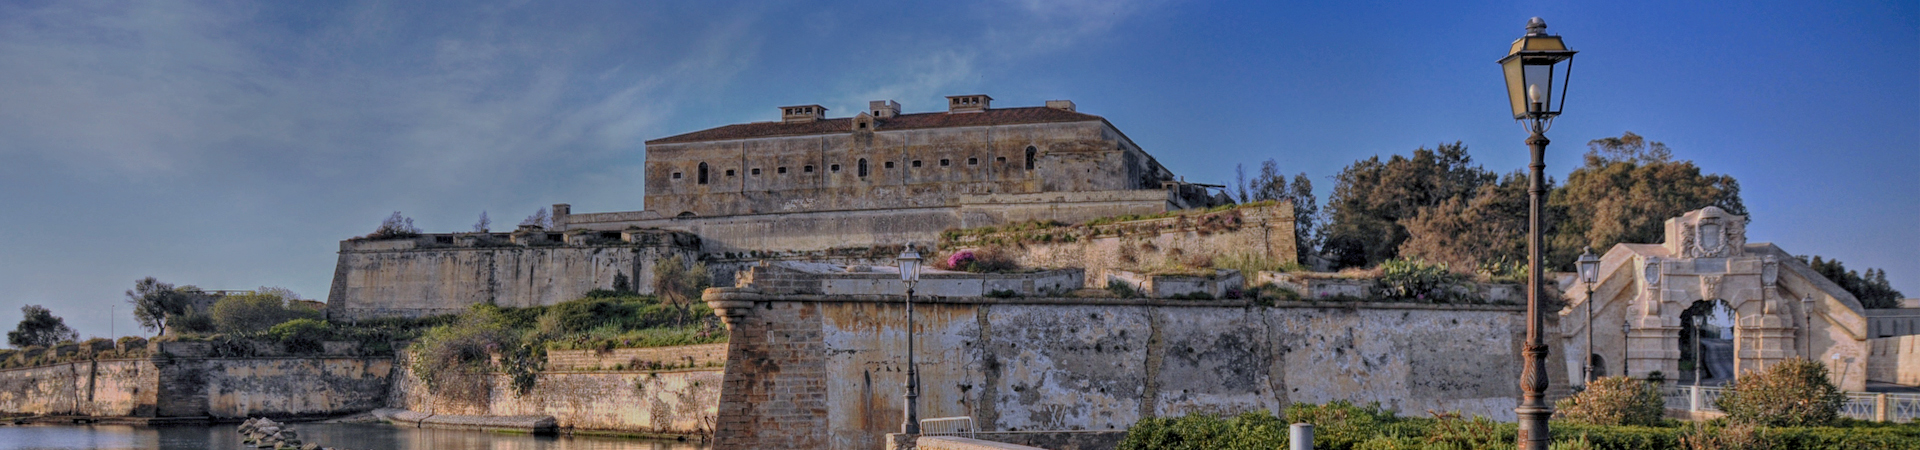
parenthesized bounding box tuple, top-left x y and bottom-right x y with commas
(326, 233, 699, 319)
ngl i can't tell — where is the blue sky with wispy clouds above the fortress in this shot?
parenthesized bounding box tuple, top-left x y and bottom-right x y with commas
(0, 0, 1920, 337)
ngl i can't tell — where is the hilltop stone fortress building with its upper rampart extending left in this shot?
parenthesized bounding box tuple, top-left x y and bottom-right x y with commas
(328, 94, 1228, 317)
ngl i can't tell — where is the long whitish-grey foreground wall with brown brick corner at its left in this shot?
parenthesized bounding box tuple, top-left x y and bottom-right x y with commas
(707, 288, 1543, 448)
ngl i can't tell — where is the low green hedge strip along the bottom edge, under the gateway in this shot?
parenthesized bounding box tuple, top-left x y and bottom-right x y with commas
(1119, 402, 1920, 450)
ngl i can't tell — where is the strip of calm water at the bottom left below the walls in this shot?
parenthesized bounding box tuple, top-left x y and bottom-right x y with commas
(0, 423, 708, 450)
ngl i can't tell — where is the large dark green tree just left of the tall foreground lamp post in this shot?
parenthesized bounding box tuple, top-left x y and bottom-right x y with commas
(1321, 142, 1498, 269)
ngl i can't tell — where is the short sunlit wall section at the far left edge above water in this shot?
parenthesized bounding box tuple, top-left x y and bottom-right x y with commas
(0, 360, 156, 415)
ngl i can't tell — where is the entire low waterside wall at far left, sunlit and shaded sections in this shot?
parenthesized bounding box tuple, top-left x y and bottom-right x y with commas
(0, 342, 394, 419)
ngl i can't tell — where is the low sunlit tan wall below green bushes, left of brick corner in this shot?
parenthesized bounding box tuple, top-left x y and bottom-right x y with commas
(390, 351, 722, 435)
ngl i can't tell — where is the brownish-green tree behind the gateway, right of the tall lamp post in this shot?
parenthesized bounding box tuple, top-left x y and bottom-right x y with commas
(1548, 131, 1747, 269)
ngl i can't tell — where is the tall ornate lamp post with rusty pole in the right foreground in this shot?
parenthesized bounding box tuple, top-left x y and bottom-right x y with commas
(1500, 17, 1574, 450)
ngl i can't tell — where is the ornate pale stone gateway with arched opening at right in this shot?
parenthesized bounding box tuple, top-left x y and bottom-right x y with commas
(1557, 206, 1868, 390)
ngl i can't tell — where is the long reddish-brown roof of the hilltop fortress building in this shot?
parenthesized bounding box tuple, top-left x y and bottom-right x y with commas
(647, 106, 1104, 144)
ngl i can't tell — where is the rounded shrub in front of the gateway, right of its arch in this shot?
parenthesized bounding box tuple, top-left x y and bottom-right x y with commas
(1715, 358, 1847, 427)
